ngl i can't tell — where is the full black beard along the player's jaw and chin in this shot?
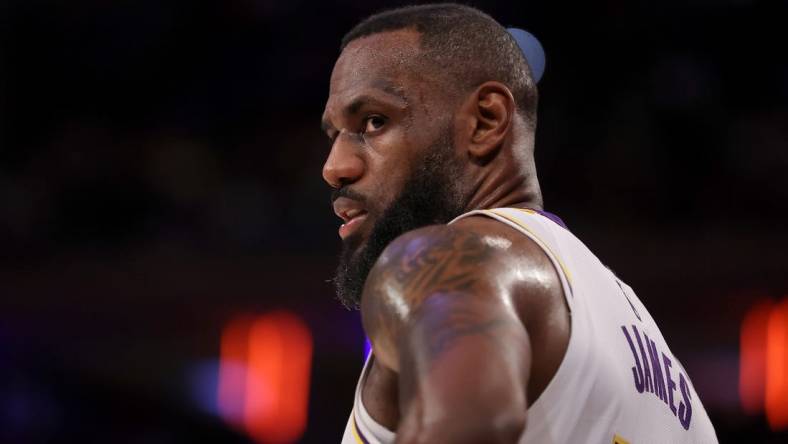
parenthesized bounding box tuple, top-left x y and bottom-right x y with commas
(333, 134, 465, 309)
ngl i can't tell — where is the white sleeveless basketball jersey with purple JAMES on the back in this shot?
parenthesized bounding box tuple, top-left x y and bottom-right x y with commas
(342, 208, 717, 444)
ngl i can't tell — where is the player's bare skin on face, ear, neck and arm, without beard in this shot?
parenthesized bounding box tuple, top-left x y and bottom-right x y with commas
(323, 30, 570, 443)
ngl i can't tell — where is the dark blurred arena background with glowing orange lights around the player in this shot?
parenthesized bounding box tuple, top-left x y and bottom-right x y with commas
(0, 0, 788, 443)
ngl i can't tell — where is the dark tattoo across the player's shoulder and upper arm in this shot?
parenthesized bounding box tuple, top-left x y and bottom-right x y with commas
(362, 226, 512, 360)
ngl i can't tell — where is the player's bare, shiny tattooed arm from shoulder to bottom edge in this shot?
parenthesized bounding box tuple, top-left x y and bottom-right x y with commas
(362, 221, 544, 444)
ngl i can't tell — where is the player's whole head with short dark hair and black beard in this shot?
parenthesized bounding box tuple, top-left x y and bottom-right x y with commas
(323, 4, 538, 306)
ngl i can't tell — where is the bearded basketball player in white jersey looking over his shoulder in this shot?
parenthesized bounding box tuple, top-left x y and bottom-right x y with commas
(323, 4, 717, 444)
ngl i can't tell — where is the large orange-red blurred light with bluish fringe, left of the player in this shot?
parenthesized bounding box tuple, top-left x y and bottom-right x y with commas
(218, 311, 312, 443)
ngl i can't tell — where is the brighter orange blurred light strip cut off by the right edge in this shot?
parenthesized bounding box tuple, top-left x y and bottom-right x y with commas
(766, 299, 788, 430)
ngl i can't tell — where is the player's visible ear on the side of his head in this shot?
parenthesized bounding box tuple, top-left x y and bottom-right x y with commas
(464, 81, 515, 159)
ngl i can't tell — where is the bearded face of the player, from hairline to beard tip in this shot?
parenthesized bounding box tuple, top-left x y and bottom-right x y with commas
(323, 31, 464, 307)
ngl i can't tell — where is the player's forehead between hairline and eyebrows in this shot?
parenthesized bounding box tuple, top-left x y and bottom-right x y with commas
(326, 29, 419, 111)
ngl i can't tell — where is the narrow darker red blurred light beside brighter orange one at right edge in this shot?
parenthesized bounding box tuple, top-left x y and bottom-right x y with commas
(739, 300, 772, 415)
